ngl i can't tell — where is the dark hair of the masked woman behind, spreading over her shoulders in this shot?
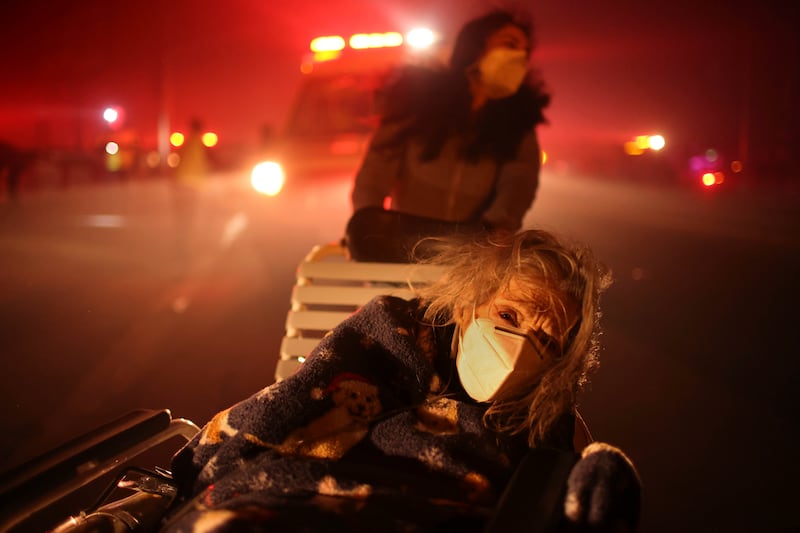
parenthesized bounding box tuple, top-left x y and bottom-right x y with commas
(380, 6, 550, 162)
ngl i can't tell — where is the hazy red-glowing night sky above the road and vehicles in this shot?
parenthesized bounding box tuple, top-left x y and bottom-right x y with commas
(0, 0, 800, 168)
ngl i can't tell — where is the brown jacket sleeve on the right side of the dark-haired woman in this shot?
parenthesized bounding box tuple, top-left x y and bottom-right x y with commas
(482, 129, 541, 231)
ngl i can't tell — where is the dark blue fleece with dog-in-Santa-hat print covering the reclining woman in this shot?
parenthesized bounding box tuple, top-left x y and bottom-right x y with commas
(164, 297, 568, 531)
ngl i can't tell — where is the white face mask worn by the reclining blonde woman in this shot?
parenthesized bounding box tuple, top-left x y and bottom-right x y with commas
(456, 311, 546, 402)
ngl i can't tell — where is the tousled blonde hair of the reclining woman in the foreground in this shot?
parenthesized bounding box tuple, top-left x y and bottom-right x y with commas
(412, 230, 611, 446)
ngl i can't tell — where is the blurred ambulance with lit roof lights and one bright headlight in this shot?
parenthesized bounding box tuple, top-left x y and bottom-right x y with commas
(250, 28, 443, 196)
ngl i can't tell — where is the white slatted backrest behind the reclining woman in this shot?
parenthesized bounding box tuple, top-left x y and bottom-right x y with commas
(275, 244, 442, 381)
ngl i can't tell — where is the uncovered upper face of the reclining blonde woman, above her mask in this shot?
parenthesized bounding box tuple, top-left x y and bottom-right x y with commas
(460, 281, 578, 358)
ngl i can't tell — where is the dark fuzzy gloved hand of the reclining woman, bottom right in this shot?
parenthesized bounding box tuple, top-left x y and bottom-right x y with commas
(564, 442, 641, 532)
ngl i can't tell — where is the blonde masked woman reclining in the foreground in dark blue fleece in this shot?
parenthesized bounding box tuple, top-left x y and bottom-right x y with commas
(167, 230, 640, 531)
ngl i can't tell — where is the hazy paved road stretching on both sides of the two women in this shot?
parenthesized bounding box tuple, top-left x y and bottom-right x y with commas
(0, 169, 800, 532)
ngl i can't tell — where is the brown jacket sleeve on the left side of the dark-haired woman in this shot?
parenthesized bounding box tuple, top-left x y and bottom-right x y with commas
(351, 120, 406, 211)
